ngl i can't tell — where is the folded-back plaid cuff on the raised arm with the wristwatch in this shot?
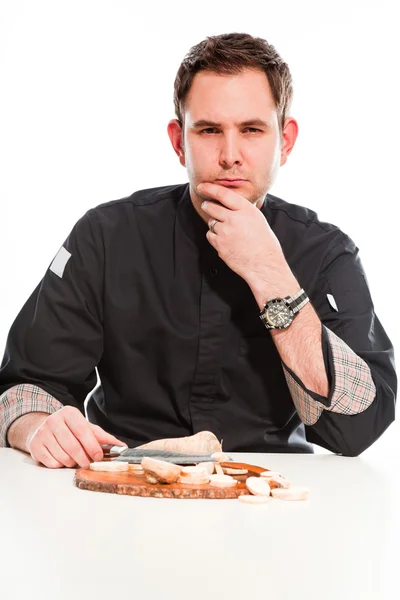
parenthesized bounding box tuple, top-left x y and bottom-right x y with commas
(282, 325, 376, 425)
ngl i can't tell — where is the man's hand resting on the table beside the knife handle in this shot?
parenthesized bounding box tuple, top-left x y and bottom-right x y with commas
(8, 406, 126, 469)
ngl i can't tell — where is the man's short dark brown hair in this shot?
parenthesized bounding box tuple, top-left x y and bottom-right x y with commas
(174, 33, 293, 132)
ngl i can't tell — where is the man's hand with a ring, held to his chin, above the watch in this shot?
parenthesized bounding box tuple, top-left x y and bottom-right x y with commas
(197, 183, 299, 302)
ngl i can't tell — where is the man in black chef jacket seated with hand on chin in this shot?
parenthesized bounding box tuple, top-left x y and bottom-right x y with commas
(0, 34, 396, 468)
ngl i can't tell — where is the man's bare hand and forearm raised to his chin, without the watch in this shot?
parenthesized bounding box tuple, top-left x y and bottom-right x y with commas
(197, 183, 329, 398)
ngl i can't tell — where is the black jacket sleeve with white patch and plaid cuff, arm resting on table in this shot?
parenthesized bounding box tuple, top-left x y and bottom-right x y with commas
(0, 211, 104, 445)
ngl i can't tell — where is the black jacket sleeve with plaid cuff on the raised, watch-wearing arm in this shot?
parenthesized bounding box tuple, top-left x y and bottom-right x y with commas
(283, 236, 397, 456)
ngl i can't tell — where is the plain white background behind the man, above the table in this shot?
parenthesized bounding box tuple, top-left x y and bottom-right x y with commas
(0, 0, 400, 452)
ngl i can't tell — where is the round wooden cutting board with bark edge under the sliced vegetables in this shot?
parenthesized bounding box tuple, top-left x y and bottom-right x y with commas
(74, 462, 278, 499)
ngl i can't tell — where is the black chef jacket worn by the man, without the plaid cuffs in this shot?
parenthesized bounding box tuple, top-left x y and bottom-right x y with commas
(0, 184, 396, 455)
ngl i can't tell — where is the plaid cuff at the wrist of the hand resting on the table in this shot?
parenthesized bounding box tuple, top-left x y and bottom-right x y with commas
(0, 383, 63, 448)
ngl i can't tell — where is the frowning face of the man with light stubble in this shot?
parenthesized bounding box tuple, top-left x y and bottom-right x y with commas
(181, 70, 286, 207)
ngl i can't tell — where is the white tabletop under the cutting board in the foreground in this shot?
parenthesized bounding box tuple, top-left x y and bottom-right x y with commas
(0, 449, 400, 600)
